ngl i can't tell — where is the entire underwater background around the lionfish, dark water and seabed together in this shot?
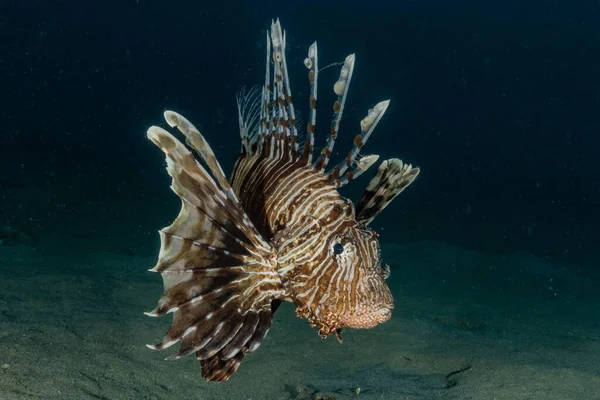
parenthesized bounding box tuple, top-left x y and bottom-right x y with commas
(0, 0, 600, 400)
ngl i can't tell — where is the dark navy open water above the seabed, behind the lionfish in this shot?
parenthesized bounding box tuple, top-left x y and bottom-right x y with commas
(0, 0, 600, 399)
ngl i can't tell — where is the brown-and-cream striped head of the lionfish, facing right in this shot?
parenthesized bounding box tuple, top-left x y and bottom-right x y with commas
(279, 201, 394, 335)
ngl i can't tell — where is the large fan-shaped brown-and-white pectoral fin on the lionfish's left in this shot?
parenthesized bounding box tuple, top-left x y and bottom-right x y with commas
(147, 111, 283, 381)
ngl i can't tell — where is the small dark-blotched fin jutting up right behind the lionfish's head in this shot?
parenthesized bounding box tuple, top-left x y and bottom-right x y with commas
(356, 158, 420, 225)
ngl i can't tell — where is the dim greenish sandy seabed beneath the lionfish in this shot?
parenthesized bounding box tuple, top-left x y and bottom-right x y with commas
(0, 237, 600, 400)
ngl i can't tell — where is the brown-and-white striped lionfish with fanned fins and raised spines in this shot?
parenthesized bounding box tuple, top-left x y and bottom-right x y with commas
(147, 20, 419, 381)
